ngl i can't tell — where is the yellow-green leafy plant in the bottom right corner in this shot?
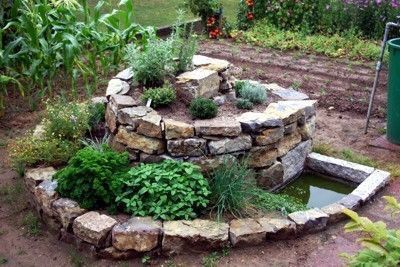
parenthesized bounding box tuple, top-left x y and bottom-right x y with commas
(342, 196, 400, 267)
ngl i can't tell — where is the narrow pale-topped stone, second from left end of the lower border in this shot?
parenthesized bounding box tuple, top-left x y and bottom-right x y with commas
(34, 180, 58, 216)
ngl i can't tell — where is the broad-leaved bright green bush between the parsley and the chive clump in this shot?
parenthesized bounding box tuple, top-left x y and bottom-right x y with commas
(117, 160, 210, 220)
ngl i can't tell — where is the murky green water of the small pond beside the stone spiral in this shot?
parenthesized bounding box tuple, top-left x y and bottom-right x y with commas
(279, 172, 356, 208)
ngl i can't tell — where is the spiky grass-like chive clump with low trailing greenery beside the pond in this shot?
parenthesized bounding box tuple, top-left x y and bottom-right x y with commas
(210, 160, 305, 218)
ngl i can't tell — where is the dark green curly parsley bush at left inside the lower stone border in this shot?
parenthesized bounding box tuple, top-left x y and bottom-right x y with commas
(54, 145, 129, 209)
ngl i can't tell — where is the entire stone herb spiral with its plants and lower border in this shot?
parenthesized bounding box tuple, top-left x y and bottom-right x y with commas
(10, 17, 390, 259)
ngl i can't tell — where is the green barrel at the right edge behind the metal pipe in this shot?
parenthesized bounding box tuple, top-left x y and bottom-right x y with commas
(386, 38, 400, 144)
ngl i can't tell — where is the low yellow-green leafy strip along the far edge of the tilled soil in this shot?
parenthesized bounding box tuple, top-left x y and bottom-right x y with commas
(234, 21, 380, 61)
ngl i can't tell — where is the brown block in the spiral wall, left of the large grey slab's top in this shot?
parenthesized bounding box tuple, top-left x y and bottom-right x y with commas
(248, 146, 278, 168)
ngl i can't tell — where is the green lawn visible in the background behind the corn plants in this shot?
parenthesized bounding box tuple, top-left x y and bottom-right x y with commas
(93, 0, 239, 27)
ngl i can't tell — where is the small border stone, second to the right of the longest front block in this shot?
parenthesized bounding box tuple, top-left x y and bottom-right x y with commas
(257, 217, 296, 240)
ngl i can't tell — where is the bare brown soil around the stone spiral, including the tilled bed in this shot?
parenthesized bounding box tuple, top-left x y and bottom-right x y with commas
(0, 41, 400, 267)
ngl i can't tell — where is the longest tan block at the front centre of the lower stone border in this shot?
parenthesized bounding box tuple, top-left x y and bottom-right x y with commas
(162, 219, 229, 254)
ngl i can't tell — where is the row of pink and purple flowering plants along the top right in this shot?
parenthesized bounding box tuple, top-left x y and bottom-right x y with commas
(238, 0, 400, 38)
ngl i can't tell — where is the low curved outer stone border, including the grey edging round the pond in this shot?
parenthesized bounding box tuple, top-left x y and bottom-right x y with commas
(25, 153, 390, 259)
